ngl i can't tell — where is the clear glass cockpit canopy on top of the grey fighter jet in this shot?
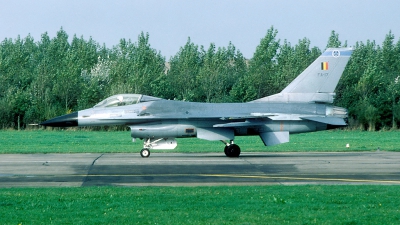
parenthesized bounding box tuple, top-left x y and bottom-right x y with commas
(94, 94, 163, 108)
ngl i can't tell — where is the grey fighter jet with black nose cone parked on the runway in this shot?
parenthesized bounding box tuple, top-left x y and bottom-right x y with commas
(41, 48, 353, 157)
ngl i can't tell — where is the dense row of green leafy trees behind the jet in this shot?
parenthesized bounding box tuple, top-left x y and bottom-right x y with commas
(0, 27, 400, 130)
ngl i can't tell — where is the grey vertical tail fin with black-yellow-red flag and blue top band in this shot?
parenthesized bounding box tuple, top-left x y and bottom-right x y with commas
(253, 48, 353, 103)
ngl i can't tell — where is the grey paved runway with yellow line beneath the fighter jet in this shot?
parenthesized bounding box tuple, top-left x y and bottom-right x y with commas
(0, 151, 400, 187)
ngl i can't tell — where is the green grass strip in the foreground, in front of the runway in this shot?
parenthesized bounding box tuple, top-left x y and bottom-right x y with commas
(0, 186, 400, 224)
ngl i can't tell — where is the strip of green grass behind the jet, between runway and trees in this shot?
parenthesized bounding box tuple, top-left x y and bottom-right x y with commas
(0, 130, 400, 154)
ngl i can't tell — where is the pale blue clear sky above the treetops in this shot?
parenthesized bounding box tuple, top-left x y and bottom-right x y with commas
(0, 0, 400, 61)
